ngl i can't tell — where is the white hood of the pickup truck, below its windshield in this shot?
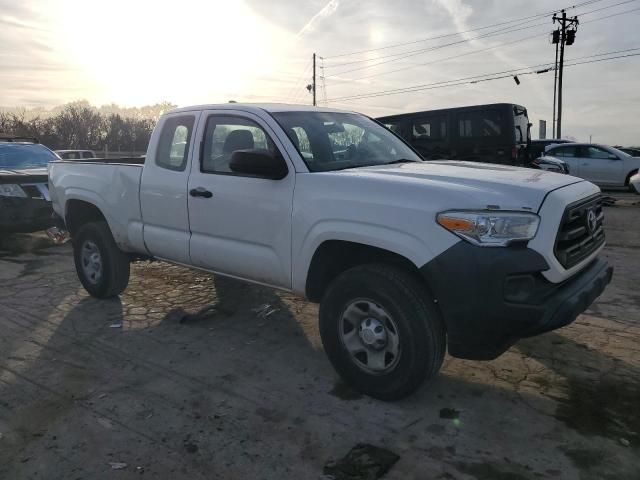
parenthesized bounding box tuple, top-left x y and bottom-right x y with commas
(340, 160, 584, 211)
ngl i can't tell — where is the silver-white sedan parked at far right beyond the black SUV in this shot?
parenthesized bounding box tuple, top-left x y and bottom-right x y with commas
(545, 143, 640, 187)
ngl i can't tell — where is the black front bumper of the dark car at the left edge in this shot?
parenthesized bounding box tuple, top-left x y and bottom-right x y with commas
(0, 196, 55, 233)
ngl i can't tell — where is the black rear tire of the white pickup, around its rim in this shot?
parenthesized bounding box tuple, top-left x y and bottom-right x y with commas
(73, 222, 130, 298)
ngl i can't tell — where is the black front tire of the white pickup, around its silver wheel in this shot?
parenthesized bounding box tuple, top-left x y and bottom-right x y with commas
(320, 264, 446, 400)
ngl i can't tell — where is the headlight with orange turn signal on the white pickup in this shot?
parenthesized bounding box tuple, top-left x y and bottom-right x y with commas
(436, 210, 540, 247)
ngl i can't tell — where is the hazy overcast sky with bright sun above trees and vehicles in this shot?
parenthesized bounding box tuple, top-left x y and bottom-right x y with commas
(0, 0, 640, 145)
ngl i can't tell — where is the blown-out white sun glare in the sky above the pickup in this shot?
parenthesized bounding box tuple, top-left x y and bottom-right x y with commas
(55, 0, 286, 105)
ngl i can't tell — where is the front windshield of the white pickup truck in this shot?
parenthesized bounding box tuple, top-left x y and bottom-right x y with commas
(273, 112, 422, 172)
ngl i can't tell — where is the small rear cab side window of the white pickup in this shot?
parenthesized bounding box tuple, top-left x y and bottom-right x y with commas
(156, 115, 195, 172)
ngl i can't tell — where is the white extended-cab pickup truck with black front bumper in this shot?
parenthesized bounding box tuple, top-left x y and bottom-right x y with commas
(49, 104, 613, 400)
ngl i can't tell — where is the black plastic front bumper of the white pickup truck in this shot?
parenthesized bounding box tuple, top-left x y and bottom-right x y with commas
(420, 241, 613, 360)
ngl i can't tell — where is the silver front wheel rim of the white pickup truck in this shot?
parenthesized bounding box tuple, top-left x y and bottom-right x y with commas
(340, 299, 400, 374)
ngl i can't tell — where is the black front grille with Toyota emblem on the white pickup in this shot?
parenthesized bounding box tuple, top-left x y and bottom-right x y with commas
(554, 194, 604, 268)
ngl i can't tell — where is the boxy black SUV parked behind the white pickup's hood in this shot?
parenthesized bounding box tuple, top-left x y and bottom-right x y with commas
(377, 103, 531, 166)
